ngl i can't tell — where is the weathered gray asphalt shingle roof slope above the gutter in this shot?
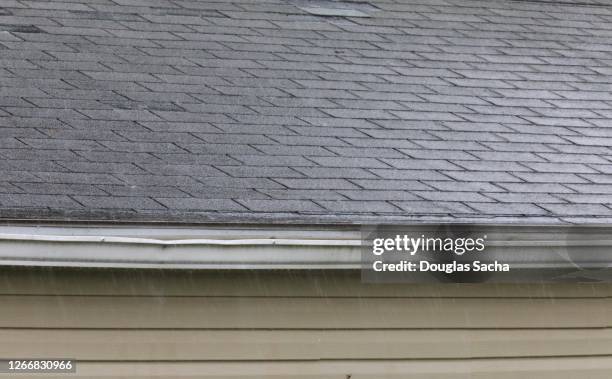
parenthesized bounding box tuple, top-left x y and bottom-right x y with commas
(0, 0, 612, 226)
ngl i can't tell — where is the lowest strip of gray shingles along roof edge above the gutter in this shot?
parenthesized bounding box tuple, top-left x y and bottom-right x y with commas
(0, 208, 612, 226)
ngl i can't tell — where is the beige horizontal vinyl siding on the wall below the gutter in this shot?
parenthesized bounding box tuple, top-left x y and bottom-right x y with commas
(0, 269, 612, 379)
